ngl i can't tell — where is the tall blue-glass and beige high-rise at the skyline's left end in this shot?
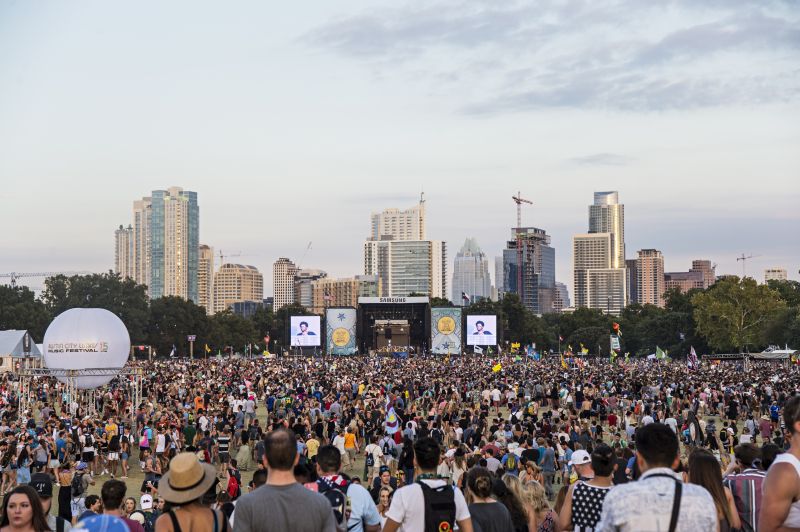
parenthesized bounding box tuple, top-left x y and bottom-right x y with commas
(119, 187, 200, 303)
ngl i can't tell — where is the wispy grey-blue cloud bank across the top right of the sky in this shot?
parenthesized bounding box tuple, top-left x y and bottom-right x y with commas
(303, 0, 800, 115)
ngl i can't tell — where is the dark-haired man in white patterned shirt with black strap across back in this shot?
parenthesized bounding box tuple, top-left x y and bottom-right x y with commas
(596, 423, 718, 532)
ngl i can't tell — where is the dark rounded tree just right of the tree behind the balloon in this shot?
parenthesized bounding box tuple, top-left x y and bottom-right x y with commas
(147, 296, 209, 357)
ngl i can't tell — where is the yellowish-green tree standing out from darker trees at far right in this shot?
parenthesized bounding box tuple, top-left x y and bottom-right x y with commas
(692, 276, 786, 351)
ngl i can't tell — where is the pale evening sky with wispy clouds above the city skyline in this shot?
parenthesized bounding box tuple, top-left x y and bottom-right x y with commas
(0, 0, 800, 295)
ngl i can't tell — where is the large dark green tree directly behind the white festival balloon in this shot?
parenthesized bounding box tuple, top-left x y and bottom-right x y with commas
(42, 271, 148, 343)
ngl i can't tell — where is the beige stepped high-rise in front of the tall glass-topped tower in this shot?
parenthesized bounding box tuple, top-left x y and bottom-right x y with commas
(572, 233, 626, 314)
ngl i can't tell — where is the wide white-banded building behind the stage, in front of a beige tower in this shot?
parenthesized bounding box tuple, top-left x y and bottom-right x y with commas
(364, 240, 447, 298)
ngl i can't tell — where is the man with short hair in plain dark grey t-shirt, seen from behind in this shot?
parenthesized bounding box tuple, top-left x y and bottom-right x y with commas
(231, 428, 334, 532)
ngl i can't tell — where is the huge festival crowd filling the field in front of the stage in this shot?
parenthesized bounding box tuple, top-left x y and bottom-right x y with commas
(0, 356, 800, 532)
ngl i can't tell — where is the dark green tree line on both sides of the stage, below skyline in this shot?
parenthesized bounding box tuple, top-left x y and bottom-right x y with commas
(0, 272, 800, 357)
